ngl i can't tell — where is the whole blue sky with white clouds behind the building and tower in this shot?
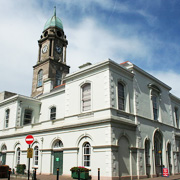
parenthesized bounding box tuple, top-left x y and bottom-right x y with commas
(0, 0, 180, 97)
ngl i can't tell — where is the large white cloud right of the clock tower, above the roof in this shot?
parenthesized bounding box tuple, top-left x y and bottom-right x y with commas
(66, 18, 151, 70)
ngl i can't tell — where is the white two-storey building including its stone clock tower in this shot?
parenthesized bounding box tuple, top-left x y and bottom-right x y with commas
(0, 7, 180, 179)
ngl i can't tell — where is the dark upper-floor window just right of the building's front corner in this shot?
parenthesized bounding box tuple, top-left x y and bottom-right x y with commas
(118, 82, 125, 111)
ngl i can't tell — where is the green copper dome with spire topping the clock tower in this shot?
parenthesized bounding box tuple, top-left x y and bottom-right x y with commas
(44, 7, 63, 30)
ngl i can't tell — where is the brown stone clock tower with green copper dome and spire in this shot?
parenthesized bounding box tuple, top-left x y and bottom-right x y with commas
(31, 8, 69, 97)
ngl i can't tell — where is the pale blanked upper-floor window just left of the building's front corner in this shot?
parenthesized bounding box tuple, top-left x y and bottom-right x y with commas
(82, 83, 91, 111)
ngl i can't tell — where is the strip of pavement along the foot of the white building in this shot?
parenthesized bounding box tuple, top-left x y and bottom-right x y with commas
(0, 174, 180, 180)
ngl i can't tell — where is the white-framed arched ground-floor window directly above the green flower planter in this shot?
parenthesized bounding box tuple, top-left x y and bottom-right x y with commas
(83, 142, 91, 167)
